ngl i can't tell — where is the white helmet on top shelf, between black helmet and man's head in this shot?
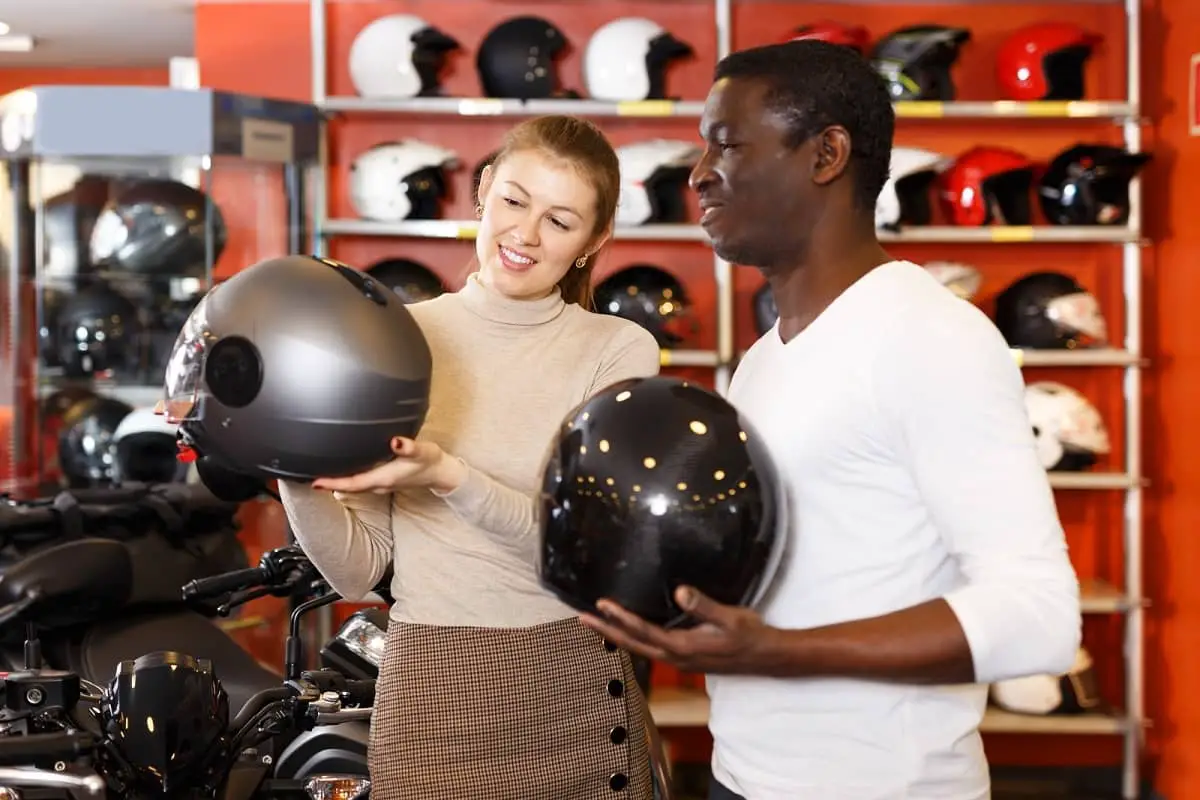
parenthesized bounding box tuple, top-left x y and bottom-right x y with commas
(583, 17, 692, 102)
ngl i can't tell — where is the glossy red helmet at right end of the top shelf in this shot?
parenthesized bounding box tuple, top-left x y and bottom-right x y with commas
(996, 23, 1103, 102)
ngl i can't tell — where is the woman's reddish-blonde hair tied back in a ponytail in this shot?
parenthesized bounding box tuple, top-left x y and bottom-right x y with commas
(492, 115, 620, 308)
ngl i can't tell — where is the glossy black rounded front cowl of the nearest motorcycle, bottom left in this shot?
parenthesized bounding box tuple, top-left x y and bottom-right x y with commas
(100, 652, 229, 796)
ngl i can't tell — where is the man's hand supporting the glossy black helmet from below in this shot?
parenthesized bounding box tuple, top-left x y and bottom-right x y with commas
(580, 587, 784, 675)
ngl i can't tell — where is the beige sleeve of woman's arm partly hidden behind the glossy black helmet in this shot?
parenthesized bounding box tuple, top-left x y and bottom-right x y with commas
(434, 325, 660, 557)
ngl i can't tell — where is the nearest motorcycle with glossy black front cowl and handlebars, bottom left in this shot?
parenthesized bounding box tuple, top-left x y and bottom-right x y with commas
(0, 539, 374, 800)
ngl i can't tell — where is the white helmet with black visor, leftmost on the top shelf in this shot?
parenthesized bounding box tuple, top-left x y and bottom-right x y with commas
(350, 14, 460, 100)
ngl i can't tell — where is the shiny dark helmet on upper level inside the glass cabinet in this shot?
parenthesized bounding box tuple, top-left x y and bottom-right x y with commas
(90, 178, 227, 278)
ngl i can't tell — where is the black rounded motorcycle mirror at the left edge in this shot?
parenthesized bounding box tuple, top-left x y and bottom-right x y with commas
(0, 539, 133, 627)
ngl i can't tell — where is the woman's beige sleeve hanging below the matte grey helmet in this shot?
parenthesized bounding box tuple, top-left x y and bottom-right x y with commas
(278, 481, 394, 602)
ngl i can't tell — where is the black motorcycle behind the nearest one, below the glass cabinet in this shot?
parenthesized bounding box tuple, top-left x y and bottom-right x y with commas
(0, 483, 280, 724)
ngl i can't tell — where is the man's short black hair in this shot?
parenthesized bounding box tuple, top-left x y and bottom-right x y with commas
(714, 40, 895, 211)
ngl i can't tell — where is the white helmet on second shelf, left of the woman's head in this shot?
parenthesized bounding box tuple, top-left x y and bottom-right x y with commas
(350, 139, 460, 222)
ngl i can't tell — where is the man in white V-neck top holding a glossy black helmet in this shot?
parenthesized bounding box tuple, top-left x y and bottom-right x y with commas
(583, 41, 1081, 800)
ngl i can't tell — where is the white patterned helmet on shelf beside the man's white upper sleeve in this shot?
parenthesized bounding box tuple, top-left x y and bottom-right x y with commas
(1025, 380, 1111, 473)
